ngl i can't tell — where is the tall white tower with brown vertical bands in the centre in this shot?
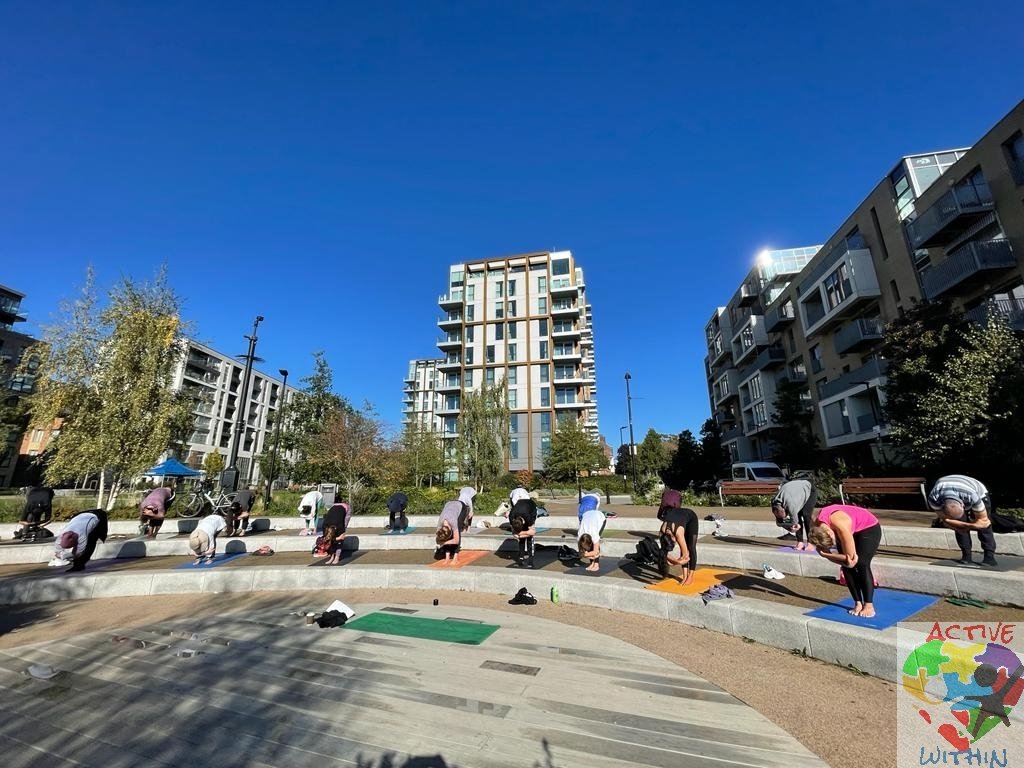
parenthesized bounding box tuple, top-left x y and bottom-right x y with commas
(434, 251, 598, 471)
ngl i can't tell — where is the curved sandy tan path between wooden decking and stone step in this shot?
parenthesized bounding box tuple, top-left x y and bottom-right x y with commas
(0, 590, 896, 768)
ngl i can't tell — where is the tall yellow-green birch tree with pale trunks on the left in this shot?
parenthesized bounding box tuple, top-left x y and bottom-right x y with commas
(27, 269, 194, 508)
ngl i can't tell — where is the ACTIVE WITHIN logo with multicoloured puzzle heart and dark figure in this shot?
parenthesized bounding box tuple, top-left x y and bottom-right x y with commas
(897, 622, 1024, 768)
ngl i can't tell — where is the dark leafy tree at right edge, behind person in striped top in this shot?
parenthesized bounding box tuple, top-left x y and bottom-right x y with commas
(884, 304, 1024, 475)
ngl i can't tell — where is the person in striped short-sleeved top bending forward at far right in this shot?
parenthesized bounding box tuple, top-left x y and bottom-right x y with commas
(928, 475, 998, 566)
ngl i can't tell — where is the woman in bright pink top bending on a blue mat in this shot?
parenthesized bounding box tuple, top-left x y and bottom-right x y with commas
(808, 504, 882, 618)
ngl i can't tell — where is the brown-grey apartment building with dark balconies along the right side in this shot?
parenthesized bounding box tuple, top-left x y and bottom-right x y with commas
(706, 102, 1024, 461)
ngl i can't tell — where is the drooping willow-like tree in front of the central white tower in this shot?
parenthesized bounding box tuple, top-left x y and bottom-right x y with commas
(455, 380, 511, 490)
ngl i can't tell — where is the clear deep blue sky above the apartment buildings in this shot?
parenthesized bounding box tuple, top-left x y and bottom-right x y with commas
(0, 0, 1024, 444)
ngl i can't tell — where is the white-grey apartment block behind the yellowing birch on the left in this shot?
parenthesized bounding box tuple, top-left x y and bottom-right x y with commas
(172, 340, 298, 482)
